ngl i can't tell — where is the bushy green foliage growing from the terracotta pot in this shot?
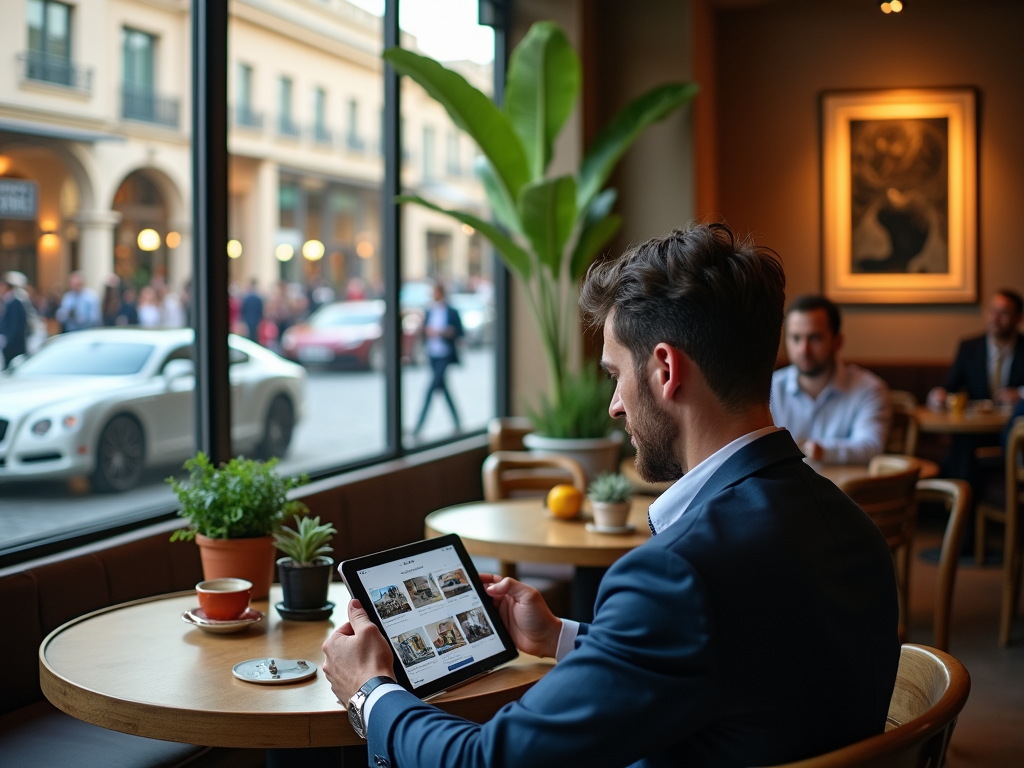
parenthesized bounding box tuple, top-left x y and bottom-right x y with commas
(167, 452, 308, 542)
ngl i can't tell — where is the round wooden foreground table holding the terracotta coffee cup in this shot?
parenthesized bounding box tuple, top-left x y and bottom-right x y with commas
(39, 584, 551, 760)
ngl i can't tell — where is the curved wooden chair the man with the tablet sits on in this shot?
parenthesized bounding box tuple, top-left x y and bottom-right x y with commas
(775, 645, 971, 768)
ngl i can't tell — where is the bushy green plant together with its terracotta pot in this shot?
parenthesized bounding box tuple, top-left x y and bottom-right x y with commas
(167, 452, 308, 600)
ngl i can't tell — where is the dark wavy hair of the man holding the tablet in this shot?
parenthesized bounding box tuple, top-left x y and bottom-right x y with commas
(580, 224, 785, 413)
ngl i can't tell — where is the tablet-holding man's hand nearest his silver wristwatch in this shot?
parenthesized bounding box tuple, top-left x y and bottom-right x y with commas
(324, 600, 394, 707)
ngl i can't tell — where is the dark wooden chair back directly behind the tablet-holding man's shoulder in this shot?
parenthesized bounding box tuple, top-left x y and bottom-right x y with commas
(840, 464, 920, 637)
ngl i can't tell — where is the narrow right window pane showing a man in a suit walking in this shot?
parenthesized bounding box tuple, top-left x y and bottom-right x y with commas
(399, 0, 496, 445)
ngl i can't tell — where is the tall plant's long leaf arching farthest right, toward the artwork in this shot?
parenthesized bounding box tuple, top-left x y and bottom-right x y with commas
(577, 83, 698, 209)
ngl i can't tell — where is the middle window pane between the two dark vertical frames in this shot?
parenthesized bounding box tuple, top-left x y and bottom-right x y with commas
(228, 3, 387, 473)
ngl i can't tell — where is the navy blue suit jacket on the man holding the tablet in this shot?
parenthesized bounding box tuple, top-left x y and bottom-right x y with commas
(369, 431, 900, 768)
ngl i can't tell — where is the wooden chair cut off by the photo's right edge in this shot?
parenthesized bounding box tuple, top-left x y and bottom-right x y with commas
(974, 421, 1024, 647)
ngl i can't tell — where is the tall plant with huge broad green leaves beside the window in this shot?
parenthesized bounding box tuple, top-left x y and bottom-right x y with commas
(384, 22, 697, 437)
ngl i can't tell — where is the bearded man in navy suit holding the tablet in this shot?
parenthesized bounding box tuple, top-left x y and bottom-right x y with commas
(324, 224, 900, 768)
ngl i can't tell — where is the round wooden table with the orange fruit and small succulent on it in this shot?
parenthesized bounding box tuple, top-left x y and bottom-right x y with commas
(425, 496, 654, 567)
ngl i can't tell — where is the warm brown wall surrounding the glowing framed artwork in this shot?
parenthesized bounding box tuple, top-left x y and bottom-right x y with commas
(715, 0, 1024, 360)
